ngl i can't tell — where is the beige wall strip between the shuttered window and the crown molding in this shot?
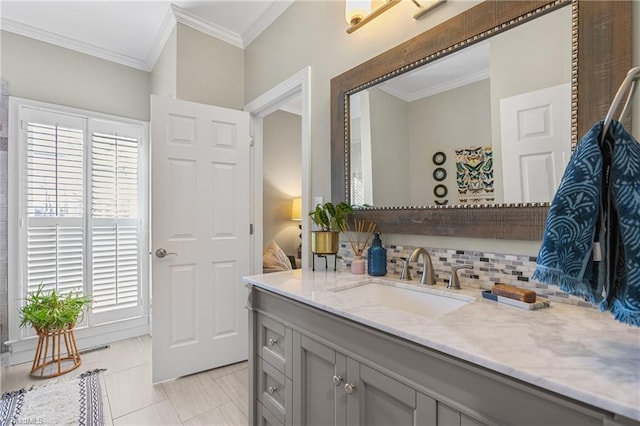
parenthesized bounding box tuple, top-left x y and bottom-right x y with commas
(1, 31, 150, 121)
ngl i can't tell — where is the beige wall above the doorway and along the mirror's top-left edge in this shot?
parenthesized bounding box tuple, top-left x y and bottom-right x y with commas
(245, 0, 478, 204)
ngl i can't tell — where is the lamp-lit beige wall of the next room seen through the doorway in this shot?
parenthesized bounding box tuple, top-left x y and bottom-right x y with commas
(263, 111, 302, 255)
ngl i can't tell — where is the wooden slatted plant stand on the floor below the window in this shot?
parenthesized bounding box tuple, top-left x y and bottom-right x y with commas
(31, 325, 82, 378)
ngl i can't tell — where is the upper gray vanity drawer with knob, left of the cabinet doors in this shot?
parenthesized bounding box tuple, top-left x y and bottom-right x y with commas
(258, 315, 291, 377)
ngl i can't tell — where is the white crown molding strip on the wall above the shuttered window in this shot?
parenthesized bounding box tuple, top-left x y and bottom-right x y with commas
(1, 18, 148, 71)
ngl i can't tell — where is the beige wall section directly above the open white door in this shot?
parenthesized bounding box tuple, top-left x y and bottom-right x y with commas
(176, 24, 245, 109)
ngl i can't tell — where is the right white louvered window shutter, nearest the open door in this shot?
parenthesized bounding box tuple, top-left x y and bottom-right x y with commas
(91, 123, 140, 313)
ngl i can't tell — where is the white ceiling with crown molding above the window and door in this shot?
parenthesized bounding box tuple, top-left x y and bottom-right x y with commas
(0, 0, 293, 71)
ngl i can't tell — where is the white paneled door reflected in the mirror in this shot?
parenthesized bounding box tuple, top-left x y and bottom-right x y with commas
(500, 83, 571, 203)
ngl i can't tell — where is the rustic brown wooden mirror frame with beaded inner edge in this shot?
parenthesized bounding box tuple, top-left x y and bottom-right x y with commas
(331, 0, 632, 241)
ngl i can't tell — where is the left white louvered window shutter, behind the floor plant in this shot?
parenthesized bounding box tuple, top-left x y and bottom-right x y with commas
(26, 111, 84, 300)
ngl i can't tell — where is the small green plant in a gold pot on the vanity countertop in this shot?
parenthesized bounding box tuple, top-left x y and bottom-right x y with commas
(309, 201, 353, 254)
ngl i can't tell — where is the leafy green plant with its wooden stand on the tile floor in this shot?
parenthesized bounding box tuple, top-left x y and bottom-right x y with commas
(20, 285, 91, 377)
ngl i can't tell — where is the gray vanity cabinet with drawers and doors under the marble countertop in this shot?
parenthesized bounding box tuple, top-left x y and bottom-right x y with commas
(248, 287, 624, 426)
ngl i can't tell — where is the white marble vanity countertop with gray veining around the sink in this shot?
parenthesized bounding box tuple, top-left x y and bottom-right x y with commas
(244, 269, 640, 421)
